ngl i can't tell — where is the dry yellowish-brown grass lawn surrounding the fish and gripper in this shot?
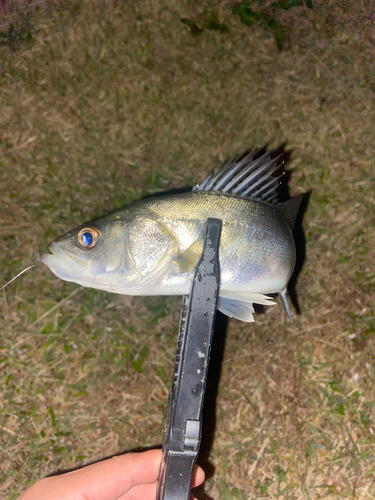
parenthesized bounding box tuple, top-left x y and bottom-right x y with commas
(0, 0, 375, 500)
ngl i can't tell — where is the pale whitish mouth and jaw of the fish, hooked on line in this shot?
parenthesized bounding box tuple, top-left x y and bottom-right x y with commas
(40, 243, 89, 281)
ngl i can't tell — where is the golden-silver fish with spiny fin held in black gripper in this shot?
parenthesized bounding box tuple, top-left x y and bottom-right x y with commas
(40, 150, 301, 322)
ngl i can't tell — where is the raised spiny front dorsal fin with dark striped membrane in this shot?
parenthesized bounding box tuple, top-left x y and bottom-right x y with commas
(193, 149, 283, 204)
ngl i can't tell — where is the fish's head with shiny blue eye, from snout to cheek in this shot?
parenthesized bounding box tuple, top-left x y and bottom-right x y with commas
(40, 215, 137, 291)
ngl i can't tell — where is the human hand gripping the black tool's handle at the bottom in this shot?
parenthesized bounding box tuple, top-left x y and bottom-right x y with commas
(18, 450, 204, 500)
